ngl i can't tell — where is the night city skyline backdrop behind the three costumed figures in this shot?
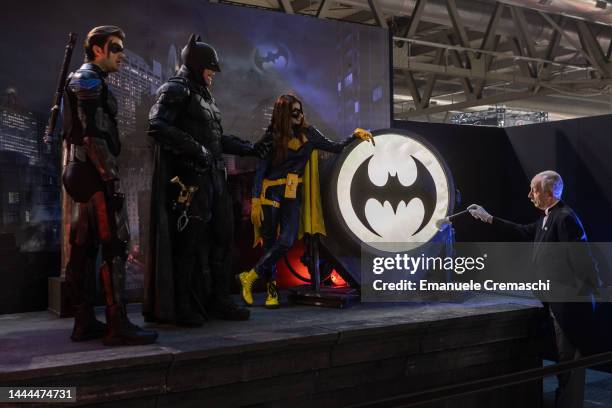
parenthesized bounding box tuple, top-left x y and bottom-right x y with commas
(0, 0, 390, 310)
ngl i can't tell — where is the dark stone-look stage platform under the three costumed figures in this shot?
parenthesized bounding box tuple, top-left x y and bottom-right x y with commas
(0, 294, 542, 408)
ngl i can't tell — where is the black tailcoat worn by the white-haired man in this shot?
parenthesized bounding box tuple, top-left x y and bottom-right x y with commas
(493, 201, 600, 354)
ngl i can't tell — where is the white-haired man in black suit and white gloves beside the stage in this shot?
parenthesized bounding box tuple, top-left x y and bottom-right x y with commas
(468, 170, 600, 408)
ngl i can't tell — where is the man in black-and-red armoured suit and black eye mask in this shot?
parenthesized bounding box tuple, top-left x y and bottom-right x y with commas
(62, 26, 157, 345)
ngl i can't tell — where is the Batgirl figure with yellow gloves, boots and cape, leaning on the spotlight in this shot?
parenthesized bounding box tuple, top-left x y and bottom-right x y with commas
(238, 95, 374, 308)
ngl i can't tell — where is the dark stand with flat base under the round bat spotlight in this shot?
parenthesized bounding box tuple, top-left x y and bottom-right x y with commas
(289, 234, 359, 309)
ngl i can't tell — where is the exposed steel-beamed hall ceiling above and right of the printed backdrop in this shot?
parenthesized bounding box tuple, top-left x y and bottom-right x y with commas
(209, 0, 612, 121)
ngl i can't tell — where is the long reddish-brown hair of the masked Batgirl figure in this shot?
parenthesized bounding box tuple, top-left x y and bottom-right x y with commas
(269, 94, 308, 164)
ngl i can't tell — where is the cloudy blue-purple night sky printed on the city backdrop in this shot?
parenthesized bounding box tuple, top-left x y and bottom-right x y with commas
(0, 0, 388, 137)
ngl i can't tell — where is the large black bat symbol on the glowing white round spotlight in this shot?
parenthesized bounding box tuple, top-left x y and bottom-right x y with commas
(350, 155, 437, 238)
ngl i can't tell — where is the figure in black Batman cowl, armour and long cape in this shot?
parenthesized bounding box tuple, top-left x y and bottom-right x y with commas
(143, 35, 266, 327)
